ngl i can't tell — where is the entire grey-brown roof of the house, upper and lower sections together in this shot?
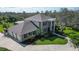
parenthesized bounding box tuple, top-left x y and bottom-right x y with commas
(8, 14, 55, 35)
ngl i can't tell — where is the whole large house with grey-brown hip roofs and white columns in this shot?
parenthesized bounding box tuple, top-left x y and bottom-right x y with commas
(8, 14, 55, 42)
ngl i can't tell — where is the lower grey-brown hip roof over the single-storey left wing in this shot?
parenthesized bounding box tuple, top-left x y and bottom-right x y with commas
(8, 22, 37, 35)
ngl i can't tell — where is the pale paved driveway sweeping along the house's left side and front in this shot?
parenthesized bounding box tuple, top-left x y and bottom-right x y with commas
(0, 33, 77, 51)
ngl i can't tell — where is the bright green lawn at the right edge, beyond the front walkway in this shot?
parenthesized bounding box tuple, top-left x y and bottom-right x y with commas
(64, 27, 79, 47)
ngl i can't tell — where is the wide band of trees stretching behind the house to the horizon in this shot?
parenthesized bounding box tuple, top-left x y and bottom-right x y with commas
(0, 8, 79, 29)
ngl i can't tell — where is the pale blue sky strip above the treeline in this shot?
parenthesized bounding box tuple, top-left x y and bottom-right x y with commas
(0, 7, 79, 13)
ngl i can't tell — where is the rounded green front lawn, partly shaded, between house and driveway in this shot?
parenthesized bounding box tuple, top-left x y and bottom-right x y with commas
(34, 36, 67, 45)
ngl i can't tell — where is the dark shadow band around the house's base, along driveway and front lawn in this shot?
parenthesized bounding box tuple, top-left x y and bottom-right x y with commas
(6, 34, 66, 47)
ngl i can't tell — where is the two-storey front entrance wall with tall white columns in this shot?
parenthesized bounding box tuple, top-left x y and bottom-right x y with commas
(41, 21, 55, 33)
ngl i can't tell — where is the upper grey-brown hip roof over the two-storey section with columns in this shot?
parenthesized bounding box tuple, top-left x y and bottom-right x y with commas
(25, 14, 55, 22)
